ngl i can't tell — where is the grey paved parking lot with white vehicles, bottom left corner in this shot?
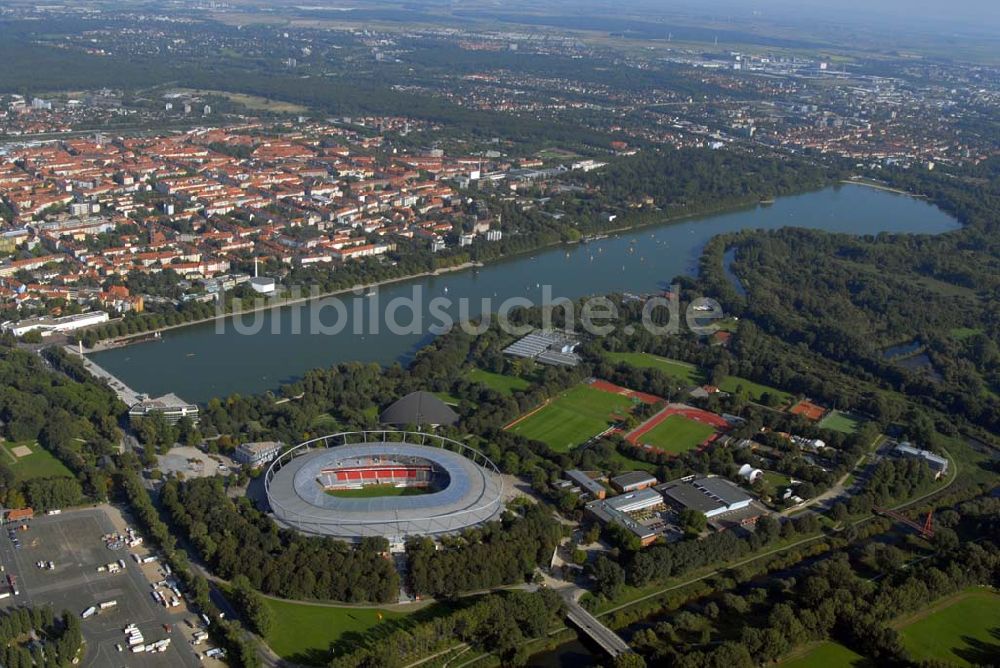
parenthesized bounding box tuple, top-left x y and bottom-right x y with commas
(0, 508, 205, 668)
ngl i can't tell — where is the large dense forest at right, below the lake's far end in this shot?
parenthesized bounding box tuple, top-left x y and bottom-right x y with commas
(702, 167, 1000, 433)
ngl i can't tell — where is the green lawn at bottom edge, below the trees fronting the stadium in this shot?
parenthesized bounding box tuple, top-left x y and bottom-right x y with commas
(264, 598, 447, 666)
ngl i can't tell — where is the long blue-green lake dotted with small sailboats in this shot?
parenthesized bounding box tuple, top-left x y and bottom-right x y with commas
(91, 185, 958, 401)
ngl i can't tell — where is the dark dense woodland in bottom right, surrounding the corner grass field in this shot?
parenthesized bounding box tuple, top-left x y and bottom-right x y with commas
(631, 497, 1000, 668)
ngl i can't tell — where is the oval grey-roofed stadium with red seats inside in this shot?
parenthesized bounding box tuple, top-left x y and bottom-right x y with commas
(264, 430, 503, 543)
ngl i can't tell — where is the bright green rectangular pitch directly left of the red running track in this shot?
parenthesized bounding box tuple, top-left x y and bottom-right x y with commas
(510, 385, 632, 452)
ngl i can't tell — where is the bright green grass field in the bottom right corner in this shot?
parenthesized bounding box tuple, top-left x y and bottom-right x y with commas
(899, 588, 1000, 666)
